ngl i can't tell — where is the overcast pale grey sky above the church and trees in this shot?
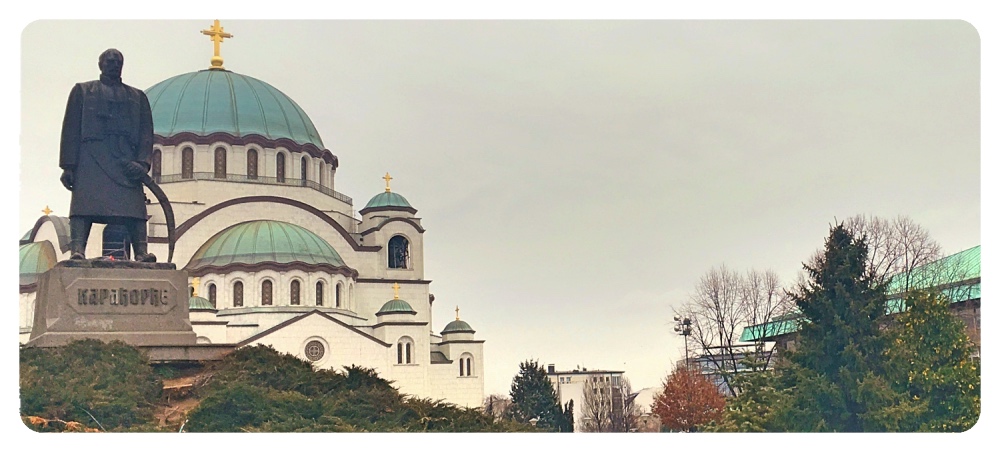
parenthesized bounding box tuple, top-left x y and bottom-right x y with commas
(11, 17, 981, 404)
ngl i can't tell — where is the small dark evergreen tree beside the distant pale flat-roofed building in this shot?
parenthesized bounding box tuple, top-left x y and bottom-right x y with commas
(510, 360, 573, 432)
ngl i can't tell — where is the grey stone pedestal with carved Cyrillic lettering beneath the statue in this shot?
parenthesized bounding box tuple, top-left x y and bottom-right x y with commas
(25, 261, 195, 347)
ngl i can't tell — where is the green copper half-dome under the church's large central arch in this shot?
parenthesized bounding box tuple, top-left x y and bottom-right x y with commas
(185, 220, 344, 271)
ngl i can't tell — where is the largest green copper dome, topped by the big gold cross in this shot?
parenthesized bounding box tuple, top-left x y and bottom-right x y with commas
(146, 69, 323, 149)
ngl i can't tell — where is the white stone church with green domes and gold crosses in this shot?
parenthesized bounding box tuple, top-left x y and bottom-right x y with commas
(20, 24, 484, 407)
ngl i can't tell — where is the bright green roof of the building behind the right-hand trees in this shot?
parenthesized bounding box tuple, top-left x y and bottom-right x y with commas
(740, 245, 981, 342)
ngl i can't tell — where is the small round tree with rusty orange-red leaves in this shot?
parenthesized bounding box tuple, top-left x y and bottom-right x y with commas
(653, 364, 726, 432)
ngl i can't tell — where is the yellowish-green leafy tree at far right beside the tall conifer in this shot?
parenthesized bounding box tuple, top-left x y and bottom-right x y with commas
(887, 291, 980, 432)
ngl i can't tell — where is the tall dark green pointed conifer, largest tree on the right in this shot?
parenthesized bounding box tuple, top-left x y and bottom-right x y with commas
(776, 225, 906, 432)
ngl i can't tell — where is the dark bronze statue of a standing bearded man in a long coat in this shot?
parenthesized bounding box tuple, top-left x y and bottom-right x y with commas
(59, 49, 156, 262)
